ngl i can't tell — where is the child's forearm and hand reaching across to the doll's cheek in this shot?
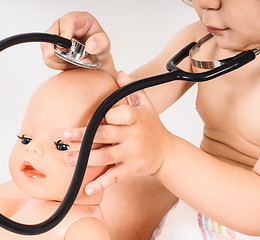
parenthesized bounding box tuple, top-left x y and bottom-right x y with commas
(86, 73, 260, 235)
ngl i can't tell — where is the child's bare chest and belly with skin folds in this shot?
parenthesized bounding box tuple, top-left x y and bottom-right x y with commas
(193, 36, 260, 169)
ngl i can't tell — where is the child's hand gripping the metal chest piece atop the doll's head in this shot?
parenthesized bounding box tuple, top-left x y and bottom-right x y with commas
(41, 12, 115, 73)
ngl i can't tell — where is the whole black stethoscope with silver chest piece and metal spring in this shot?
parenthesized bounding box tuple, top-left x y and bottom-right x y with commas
(0, 33, 260, 235)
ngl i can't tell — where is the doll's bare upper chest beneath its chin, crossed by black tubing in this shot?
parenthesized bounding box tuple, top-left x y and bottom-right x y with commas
(0, 200, 103, 240)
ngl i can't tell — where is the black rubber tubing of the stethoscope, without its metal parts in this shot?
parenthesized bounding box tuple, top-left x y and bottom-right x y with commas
(0, 33, 255, 235)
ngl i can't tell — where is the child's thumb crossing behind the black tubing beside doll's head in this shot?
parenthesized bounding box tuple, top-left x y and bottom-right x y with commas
(116, 71, 150, 106)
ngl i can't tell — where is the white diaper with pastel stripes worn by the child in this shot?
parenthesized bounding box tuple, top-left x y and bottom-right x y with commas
(151, 200, 260, 240)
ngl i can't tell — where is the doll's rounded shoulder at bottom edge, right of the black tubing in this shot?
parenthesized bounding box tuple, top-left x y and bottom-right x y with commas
(64, 217, 110, 240)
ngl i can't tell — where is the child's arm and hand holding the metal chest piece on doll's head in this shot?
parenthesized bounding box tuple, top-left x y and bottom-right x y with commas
(41, 12, 205, 114)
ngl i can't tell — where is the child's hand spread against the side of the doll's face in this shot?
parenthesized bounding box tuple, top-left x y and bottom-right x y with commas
(83, 72, 172, 195)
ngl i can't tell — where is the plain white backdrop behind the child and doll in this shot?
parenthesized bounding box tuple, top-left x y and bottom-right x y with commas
(0, 0, 202, 183)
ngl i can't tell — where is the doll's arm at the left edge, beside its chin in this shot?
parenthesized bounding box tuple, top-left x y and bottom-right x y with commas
(0, 181, 29, 217)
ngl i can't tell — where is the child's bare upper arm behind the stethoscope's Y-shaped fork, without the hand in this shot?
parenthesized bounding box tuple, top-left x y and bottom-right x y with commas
(129, 22, 206, 113)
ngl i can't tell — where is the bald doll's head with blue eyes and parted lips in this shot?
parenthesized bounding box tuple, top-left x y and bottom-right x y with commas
(9, 69, 125, 203)
